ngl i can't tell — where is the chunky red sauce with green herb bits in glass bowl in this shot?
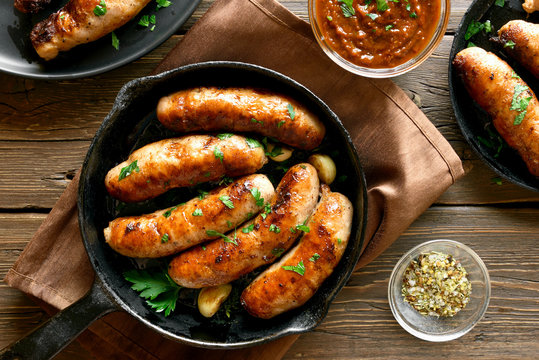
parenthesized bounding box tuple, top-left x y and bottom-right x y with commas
(315, 0, 441, 68)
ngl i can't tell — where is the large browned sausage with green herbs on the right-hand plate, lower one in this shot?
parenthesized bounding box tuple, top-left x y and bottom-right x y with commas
(453, 47, 539, 176)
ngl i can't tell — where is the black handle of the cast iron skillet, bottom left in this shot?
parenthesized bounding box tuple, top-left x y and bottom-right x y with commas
(0, 278, 118, 360)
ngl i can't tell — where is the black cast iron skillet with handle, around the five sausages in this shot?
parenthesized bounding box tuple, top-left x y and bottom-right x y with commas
(0, 62, 367, 359)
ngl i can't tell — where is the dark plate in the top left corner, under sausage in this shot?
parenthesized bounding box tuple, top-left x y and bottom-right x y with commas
(0, 0, 200, 80)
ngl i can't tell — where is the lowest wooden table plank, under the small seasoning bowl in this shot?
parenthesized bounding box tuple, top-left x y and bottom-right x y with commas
(0, 206, 539, 359)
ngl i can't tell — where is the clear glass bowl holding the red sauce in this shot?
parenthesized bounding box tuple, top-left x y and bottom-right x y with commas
(309, 0, 451, 78)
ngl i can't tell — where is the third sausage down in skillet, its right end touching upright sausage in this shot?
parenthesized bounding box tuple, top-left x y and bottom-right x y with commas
(104, 174, 275, 258)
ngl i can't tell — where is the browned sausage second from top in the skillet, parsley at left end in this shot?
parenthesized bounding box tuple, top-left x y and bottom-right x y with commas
(105, 135, 268, 202)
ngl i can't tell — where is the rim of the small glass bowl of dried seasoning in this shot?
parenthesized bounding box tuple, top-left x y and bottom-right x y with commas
(387, 239, 491, 342)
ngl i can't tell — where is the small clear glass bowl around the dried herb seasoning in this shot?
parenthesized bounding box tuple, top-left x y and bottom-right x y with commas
(388, 240, 490, 342)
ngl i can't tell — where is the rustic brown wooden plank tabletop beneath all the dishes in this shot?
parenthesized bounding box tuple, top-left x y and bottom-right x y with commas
(0, 0, 539, 360)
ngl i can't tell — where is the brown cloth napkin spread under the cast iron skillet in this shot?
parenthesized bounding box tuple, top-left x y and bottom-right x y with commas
(5, 0, 464, 360)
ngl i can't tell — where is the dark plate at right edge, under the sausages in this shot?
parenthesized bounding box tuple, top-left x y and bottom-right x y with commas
(449, 0, 539, 191)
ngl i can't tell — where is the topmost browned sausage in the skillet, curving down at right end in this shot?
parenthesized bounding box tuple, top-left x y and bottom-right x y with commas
(157, 87, 326, 150)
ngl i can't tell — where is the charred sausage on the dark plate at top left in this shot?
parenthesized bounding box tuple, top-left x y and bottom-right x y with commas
(30, 0, 150, 60)
